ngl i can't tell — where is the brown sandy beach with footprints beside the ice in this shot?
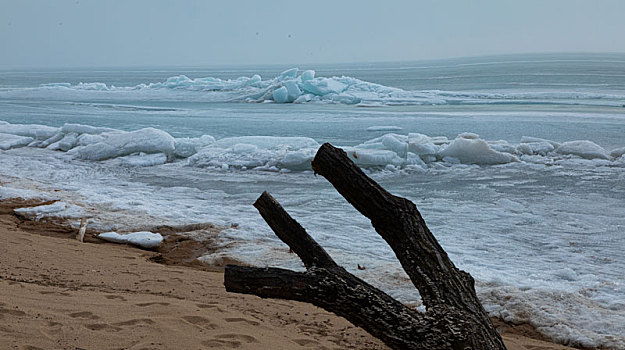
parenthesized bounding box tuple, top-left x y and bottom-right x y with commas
(0, 200, 569, 350)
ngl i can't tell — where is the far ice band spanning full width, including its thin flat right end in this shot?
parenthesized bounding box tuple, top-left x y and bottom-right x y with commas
(0, 68, 625, 107)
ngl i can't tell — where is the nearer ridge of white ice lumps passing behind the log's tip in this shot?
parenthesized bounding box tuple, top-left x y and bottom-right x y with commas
(0, 122, 625, 171)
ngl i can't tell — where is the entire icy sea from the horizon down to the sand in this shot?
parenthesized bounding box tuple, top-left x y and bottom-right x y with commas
(0, 55, 625, 348)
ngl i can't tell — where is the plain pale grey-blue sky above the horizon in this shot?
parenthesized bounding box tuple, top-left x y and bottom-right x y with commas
(0, 0, 625, 68)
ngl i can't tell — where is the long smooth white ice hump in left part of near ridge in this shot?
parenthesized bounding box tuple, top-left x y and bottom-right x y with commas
(72, 128, 175, 160)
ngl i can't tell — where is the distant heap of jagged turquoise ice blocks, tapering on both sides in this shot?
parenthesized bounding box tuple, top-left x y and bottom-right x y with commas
(30, 68, 447, 106)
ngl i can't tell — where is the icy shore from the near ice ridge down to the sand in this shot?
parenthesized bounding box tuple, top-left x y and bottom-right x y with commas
(0, 122, 625, 348)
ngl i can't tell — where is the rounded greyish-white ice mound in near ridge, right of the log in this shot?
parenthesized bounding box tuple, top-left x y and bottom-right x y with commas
(439, 138, 517, 164)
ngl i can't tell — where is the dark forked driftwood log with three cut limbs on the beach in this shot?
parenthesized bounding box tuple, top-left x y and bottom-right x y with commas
(224, 143, 505, 350)
